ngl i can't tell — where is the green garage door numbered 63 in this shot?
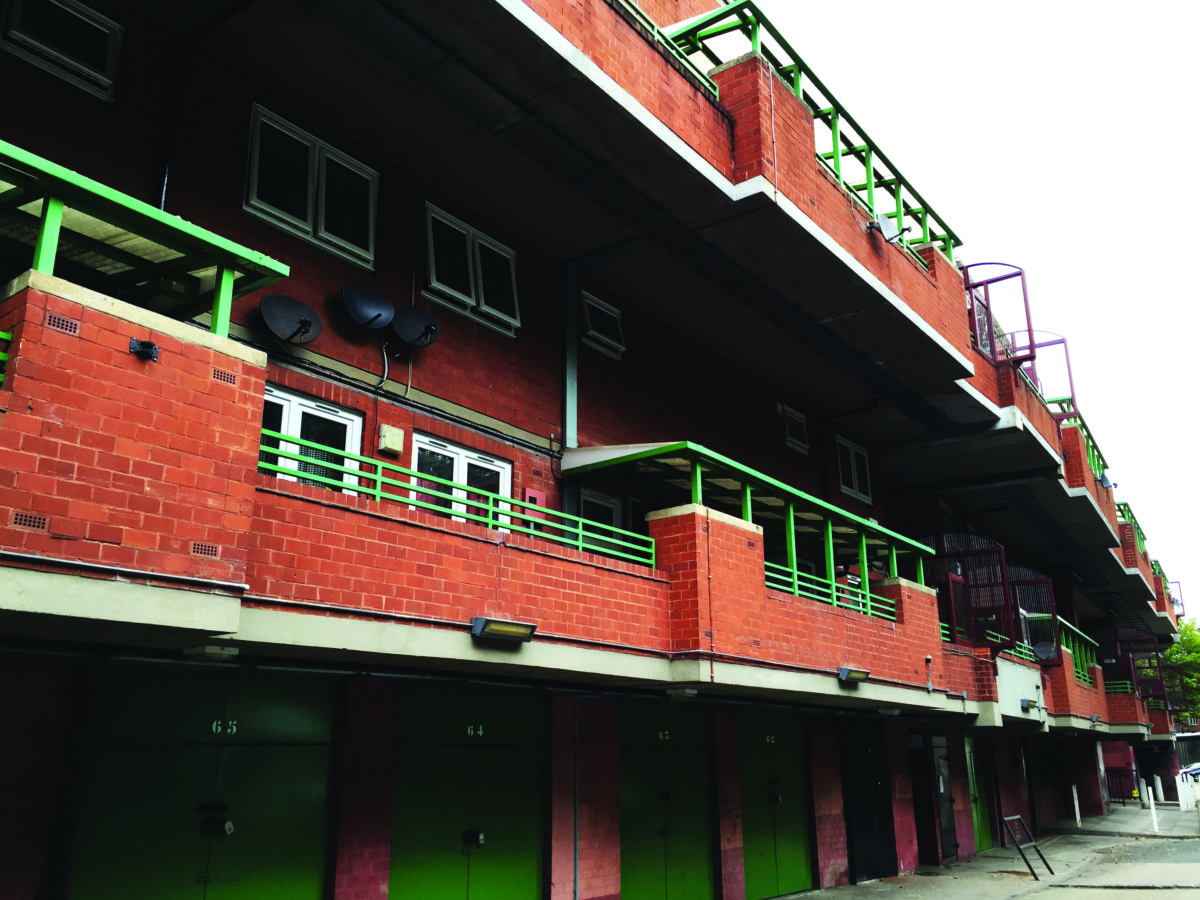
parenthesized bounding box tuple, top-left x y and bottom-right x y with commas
(620, 701, 713, 900)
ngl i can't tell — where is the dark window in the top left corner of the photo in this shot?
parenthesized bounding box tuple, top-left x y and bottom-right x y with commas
(0, 0, 125, 100)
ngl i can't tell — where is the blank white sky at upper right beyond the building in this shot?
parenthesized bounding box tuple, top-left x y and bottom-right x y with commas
(758, 0, 1200, 618)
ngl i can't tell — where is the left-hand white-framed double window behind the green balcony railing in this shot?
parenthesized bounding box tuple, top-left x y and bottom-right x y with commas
(266, 385, 362, 485)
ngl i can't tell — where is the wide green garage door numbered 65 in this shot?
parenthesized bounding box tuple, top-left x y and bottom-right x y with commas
(70, 668, 334, 900)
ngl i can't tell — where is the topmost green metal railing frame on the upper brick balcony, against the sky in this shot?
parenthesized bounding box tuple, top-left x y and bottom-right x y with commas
(670, 0, 962, 265)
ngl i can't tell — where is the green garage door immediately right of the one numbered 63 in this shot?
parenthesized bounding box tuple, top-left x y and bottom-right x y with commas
(738, 709, 812, 900)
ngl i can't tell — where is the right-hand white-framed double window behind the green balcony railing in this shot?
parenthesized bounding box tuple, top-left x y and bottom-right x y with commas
(413, 434, 512, 522)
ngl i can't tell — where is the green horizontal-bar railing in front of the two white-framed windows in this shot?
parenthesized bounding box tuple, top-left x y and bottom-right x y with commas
(258, 428, 655, 568)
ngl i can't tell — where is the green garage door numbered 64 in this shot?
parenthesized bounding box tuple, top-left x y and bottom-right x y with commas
(388, 685, 546, 900)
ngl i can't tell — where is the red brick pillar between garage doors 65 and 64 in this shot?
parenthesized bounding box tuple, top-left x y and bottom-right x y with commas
(334, 679, 400, 900)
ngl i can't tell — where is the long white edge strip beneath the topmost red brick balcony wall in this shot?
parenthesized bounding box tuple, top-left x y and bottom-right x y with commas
(496, 0, 974, 372)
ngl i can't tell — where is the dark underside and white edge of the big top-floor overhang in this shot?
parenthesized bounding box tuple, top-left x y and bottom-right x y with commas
(121, 0, 973, 440)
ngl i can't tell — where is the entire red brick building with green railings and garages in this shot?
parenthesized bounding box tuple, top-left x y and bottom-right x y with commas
(0, 0, 1181, 900)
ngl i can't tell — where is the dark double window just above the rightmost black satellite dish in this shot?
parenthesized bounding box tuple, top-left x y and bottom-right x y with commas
(425, 205, 521, 335)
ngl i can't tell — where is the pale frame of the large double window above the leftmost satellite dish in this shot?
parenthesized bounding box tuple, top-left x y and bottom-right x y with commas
(245, 103, 379, 269)
